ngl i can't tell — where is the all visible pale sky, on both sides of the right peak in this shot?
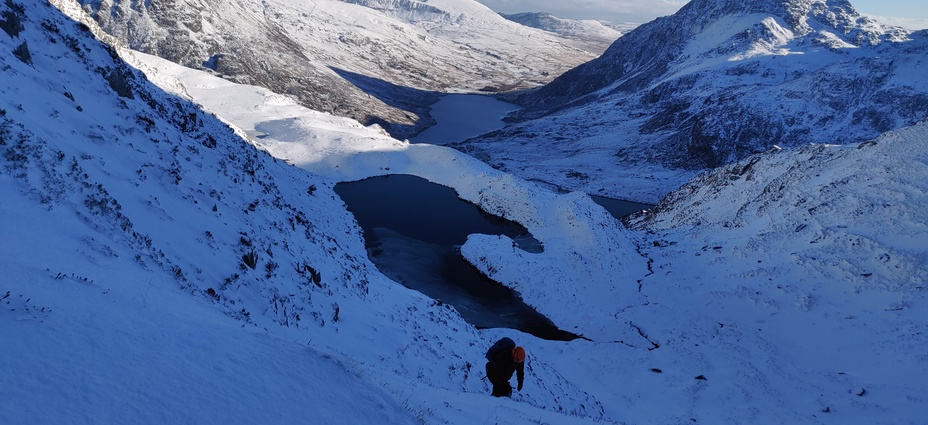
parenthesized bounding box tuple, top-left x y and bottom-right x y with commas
(477, 0, 928, 23)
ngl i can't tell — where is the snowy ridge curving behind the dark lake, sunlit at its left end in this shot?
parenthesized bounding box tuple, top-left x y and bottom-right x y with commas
(130, 48, 647, 339)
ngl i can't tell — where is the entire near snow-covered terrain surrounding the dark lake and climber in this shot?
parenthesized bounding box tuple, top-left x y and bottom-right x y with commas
(7, 0, 928, 425)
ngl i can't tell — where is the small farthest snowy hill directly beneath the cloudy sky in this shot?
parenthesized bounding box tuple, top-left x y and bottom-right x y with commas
(502, 12, 622, 54)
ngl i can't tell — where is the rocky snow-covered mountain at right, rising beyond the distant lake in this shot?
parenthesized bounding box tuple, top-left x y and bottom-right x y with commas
(464, 0, 928, 201)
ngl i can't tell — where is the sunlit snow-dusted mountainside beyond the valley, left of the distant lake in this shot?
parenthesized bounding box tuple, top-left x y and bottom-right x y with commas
(72, 0, 598, 137)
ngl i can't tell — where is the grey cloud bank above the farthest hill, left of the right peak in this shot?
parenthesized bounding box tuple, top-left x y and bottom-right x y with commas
(477, 0, 686, 23)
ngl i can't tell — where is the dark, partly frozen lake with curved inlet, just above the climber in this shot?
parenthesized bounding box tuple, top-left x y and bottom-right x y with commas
(335, 174, 577, 340)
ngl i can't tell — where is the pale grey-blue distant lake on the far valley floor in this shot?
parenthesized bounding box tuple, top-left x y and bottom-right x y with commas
(409, 94, 519, 145)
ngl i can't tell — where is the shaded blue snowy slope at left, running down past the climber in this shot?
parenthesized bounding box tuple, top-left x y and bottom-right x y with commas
(0, 1, 616, 423)
